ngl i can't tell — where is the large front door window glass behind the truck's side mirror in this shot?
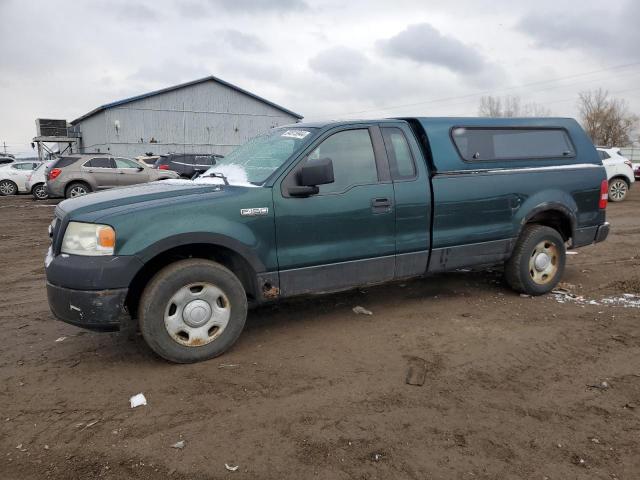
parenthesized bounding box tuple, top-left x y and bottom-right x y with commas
(309, 128, 378, 194)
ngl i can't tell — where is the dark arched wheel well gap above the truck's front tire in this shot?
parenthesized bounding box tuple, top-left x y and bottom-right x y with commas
(125, 243, 257, 318)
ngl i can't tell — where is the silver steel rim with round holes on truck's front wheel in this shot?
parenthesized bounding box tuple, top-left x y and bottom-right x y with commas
(164, 283, 231, 347)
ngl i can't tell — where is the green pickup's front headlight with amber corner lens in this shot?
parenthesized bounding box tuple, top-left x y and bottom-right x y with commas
(61, 222, 116, 256)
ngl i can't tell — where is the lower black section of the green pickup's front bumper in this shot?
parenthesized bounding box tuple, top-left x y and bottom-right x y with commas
(47, 282, 128, 332)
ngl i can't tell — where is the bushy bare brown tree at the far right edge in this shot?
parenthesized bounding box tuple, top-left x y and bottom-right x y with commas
(578, 88, 638, 147)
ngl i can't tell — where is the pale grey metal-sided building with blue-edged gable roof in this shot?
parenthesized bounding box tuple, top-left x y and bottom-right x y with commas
(71, 76, 302, 157)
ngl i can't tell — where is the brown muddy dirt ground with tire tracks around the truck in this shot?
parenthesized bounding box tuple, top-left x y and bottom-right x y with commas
(0, 192, 640, 480)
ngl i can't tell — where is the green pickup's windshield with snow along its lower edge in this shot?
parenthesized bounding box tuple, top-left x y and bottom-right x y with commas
(203, 127, 315, 184)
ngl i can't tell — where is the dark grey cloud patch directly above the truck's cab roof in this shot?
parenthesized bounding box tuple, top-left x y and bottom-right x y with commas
(377, 23, 486, 74)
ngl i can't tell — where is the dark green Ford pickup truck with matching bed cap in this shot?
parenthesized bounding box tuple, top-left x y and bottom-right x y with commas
(45, 118, 609, 363)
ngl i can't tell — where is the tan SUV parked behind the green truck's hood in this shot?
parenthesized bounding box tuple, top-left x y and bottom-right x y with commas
(47, 154, 178, 198)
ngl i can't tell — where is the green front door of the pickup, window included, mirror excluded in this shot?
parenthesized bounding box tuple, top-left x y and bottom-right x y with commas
(274, 125, 396, 296)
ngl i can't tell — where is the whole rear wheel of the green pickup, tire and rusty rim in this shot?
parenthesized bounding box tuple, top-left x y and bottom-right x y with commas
(504, 225, 567, 295)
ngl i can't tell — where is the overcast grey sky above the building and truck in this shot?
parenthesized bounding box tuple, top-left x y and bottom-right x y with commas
(0, 0, 640, 154)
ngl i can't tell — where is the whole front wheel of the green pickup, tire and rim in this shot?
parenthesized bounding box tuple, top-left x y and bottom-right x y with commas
(138, 259, 247, 363)
